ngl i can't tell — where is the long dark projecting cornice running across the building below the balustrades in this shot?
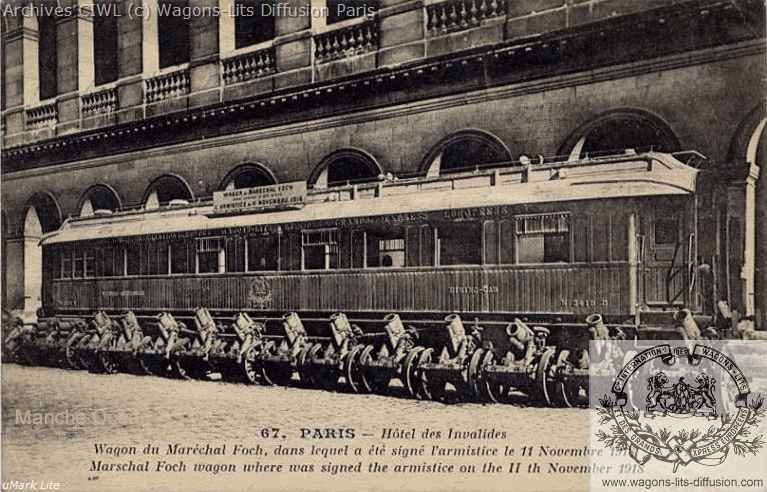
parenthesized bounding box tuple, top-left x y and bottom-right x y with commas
(2, 3, 765, 175)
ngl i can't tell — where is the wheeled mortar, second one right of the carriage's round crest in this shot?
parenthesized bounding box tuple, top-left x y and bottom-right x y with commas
(298, 313, 362, 390)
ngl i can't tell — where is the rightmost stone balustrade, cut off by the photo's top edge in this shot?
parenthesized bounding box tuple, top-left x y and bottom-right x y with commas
(426, 0, 506, 36)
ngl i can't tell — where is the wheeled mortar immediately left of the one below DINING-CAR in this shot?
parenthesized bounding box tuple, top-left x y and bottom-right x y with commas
(345, 313, 416, 394)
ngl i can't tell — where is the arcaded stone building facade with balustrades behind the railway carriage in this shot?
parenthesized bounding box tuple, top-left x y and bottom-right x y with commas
(2, 0, 767, 326)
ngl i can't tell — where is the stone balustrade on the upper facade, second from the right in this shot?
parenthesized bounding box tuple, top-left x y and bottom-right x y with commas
(314, 19, 378, 63)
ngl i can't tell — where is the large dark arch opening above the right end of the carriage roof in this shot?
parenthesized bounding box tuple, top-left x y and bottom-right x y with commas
(558, 108, 681, 160)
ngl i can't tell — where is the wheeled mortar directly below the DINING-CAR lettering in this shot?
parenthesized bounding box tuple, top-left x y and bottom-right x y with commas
(405, 314, 482, 402)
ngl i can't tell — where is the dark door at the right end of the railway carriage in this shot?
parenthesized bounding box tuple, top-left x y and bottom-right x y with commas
(642, 214, 689, 308)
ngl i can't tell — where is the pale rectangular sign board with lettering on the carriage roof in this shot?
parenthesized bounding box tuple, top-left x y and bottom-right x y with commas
(213, 181, 306, 214)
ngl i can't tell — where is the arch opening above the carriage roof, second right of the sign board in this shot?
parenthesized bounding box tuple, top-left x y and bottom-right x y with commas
(419, 129, 512, 176)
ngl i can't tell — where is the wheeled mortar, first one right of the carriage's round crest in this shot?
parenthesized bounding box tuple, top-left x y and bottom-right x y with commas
(258, 313, 311, 385)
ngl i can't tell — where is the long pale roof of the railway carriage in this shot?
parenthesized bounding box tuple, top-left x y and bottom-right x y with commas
(41, 152, 698, 244)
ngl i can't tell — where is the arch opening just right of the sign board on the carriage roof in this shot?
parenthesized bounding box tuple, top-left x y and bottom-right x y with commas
(309, 148, 383, 188)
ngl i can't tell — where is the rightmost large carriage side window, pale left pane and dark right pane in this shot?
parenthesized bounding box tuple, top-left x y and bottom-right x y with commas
(516, 213, 570, 263)
